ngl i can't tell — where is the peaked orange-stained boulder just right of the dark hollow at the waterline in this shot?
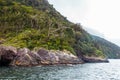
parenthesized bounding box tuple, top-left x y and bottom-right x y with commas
(13, 48, 40, 66)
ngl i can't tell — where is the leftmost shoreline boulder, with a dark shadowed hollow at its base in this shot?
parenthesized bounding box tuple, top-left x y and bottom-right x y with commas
(0, 46, 17, 66)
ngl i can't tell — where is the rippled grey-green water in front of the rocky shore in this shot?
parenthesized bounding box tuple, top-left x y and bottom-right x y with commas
(0, 60, 120, 80)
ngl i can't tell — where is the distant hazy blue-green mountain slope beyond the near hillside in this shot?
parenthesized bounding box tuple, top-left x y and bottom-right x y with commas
(93, 36, 120, 58)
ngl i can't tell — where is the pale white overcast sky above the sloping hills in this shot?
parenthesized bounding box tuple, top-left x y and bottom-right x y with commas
(48, 0, 120, 46)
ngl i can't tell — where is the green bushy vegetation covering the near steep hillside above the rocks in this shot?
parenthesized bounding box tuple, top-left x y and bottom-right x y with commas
(0, 0, 119, 57)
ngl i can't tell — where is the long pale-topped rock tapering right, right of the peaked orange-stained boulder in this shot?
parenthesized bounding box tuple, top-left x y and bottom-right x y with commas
(37, 49, 83, 65)
